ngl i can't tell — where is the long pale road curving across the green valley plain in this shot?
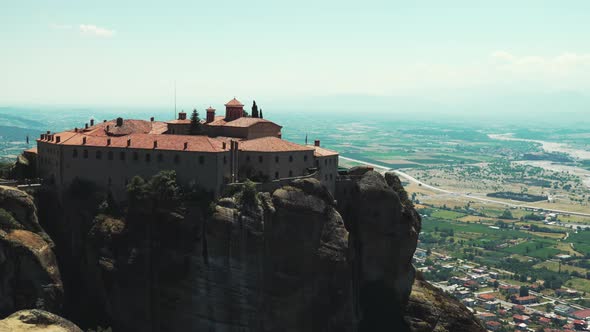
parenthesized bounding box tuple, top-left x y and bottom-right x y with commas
(340, 156, 590, 218)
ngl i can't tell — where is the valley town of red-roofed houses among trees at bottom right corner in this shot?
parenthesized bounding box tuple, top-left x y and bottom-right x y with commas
(414, 248, 590, 332)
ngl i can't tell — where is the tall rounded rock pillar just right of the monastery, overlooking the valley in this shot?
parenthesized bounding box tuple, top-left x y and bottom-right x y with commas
(337, 167, 421, 331)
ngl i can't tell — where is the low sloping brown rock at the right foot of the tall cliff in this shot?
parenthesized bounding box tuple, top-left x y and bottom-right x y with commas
(404, 280, 486, 332)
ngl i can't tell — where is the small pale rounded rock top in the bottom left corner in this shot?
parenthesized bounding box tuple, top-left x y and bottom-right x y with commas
(0, 309, 82, 332)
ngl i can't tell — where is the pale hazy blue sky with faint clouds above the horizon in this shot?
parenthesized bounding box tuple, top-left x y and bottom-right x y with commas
(0, 0, 590, 111)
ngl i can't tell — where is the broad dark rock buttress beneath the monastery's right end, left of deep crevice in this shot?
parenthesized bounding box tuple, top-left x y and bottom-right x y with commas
(155, 180, 354, 331)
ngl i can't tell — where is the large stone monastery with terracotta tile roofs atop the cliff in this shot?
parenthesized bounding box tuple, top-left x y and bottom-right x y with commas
(29, 98, 338, 200)
